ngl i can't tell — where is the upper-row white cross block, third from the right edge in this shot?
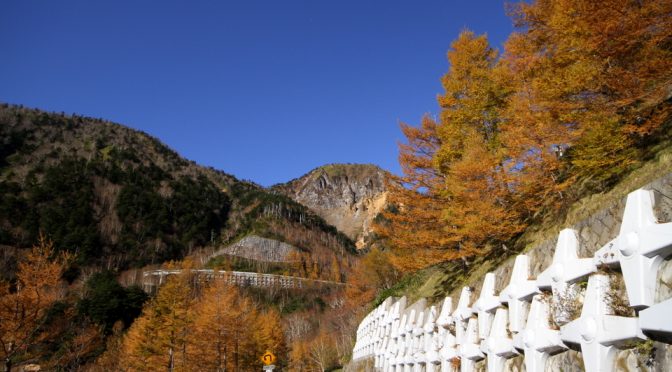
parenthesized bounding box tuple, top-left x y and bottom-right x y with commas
(499, 254, 539, 332)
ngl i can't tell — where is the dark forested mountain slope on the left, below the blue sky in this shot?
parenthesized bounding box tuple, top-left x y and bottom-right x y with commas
(0, 104, 354, 273)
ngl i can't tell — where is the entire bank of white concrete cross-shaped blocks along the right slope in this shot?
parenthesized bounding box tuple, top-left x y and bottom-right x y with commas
(353, 190, 672, 372)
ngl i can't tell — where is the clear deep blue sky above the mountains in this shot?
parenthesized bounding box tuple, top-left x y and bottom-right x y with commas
(0, 0, 512, 185)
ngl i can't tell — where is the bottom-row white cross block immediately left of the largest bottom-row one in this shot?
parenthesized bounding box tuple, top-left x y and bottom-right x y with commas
(513, 294, 566, 371)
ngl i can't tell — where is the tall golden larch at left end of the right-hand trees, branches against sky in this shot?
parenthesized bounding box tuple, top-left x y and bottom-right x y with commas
(377, 31, 522, 270)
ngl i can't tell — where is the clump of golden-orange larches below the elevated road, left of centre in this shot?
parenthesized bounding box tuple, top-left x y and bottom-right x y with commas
(121, 276, 286, 371)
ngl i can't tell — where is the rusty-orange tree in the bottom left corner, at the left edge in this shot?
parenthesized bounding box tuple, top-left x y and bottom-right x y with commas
(0, 235, 71, 371)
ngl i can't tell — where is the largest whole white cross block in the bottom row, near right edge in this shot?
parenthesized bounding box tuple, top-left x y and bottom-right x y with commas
(560, 274, 646, 372)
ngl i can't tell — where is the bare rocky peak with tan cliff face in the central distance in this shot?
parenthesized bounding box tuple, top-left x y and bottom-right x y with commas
(273, 164, 387, 248)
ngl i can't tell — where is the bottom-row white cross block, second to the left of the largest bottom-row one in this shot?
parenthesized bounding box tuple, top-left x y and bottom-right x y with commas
(481, 308, 518, 372)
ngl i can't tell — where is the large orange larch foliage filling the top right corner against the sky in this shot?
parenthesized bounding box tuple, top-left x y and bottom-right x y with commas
(504, 0, 672, 196)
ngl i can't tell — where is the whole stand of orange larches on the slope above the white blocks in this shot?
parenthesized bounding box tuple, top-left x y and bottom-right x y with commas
(376, 0, 672, 272)
